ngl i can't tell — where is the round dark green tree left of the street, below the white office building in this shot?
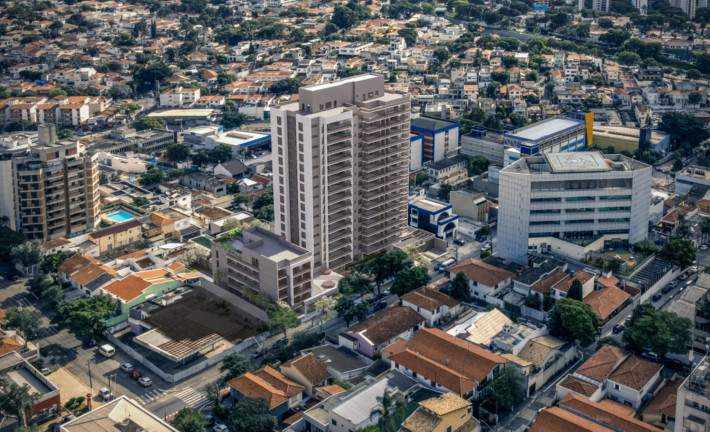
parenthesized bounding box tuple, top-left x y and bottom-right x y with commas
(550, 298, 599, 347)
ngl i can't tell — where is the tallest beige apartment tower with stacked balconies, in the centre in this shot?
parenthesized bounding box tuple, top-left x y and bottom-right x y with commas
(271, 74, 411, 272)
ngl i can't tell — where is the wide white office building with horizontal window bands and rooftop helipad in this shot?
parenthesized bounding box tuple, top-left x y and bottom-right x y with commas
(498, 152, 651, 263)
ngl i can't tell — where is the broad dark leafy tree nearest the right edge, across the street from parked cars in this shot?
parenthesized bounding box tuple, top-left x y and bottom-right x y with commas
(623, 304, 693, 360)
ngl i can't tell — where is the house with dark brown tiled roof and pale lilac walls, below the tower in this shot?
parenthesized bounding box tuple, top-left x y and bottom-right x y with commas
(338, 306, 425, 358)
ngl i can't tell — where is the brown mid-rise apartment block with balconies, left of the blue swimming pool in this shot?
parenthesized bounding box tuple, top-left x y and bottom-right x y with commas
(12, 125, 99, 240)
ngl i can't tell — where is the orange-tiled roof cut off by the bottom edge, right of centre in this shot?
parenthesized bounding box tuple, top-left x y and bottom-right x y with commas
(528, 394, 659, 432)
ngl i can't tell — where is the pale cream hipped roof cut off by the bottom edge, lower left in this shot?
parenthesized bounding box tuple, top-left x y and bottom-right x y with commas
(59, 396, 178, 432)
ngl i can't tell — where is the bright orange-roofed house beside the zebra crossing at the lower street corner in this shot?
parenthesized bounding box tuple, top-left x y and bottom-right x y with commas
(227, 366, 305, 418)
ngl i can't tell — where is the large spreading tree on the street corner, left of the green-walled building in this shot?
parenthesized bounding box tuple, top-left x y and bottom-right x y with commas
(52, 295, 118, 337)
